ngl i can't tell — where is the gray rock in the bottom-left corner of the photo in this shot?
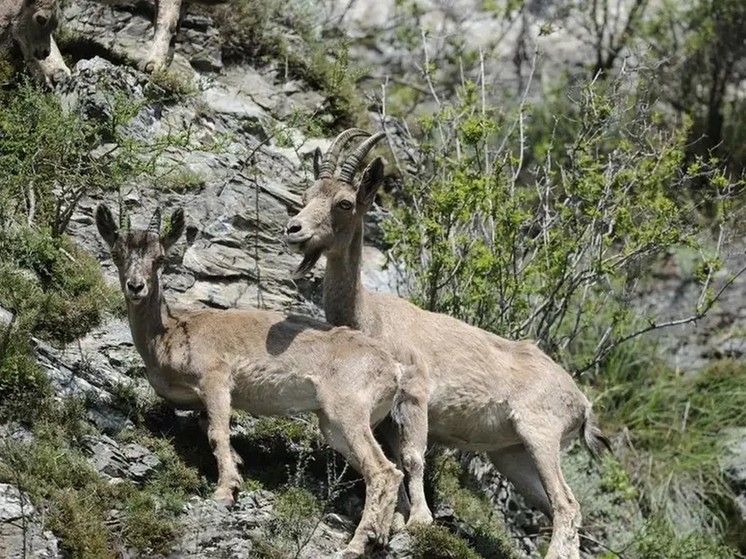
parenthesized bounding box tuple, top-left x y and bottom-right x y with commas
(0, 483, 61, 559)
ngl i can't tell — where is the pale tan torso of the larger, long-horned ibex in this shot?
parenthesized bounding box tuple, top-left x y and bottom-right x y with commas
(364, 293, 590, 450)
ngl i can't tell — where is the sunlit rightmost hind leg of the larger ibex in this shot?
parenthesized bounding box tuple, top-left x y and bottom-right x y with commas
(515, 422, 581, 559)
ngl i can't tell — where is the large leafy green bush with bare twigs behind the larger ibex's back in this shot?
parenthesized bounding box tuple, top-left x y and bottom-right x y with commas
(387, 69, 734, 371)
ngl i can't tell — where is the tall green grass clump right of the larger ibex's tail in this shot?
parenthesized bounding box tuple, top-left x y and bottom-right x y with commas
(597, 344, 746, 545)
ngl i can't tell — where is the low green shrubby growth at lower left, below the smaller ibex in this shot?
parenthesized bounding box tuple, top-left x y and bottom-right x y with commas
(0, 401, 205, 559)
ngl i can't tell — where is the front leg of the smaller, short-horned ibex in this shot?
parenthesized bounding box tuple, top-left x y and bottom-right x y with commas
(200, 371, 241, 505)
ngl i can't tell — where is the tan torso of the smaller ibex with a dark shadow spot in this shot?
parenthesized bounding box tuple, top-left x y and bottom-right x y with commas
(162, 310, 398, 414)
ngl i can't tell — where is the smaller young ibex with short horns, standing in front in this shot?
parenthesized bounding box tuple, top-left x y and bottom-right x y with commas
(96, 205, 407, 557)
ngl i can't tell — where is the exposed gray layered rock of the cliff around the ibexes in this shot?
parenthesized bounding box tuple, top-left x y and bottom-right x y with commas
(0, 0, 744, 558)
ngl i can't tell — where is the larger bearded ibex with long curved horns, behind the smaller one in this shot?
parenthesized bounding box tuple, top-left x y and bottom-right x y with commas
(286, 131, 608, 559)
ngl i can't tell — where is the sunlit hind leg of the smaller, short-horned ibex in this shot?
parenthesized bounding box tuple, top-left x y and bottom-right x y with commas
(319, 404, 403, 558)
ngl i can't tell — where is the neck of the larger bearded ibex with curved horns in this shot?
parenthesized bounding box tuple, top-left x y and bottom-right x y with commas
(324, 224, 372, 329)
